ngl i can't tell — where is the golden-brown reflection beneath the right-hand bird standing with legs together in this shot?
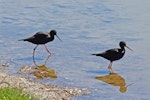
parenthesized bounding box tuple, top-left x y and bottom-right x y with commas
(95, 73, 133, 93)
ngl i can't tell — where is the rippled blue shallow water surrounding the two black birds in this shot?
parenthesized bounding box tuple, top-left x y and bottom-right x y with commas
(0, 0, 150, 100)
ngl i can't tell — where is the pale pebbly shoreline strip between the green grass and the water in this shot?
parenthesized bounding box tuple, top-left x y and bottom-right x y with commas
(0, 65, 88, 100)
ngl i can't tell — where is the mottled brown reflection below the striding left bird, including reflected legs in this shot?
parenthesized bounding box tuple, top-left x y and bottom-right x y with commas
(18, 55, 57, 79)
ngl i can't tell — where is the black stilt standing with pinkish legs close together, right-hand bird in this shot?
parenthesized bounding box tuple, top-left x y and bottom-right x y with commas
(92, 41, 133, 72)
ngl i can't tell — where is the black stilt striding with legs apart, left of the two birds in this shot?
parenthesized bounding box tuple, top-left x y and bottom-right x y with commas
(19, 30, 62, 64)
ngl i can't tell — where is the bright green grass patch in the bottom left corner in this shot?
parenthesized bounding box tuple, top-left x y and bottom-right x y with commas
(0, 87, 39, 100)
